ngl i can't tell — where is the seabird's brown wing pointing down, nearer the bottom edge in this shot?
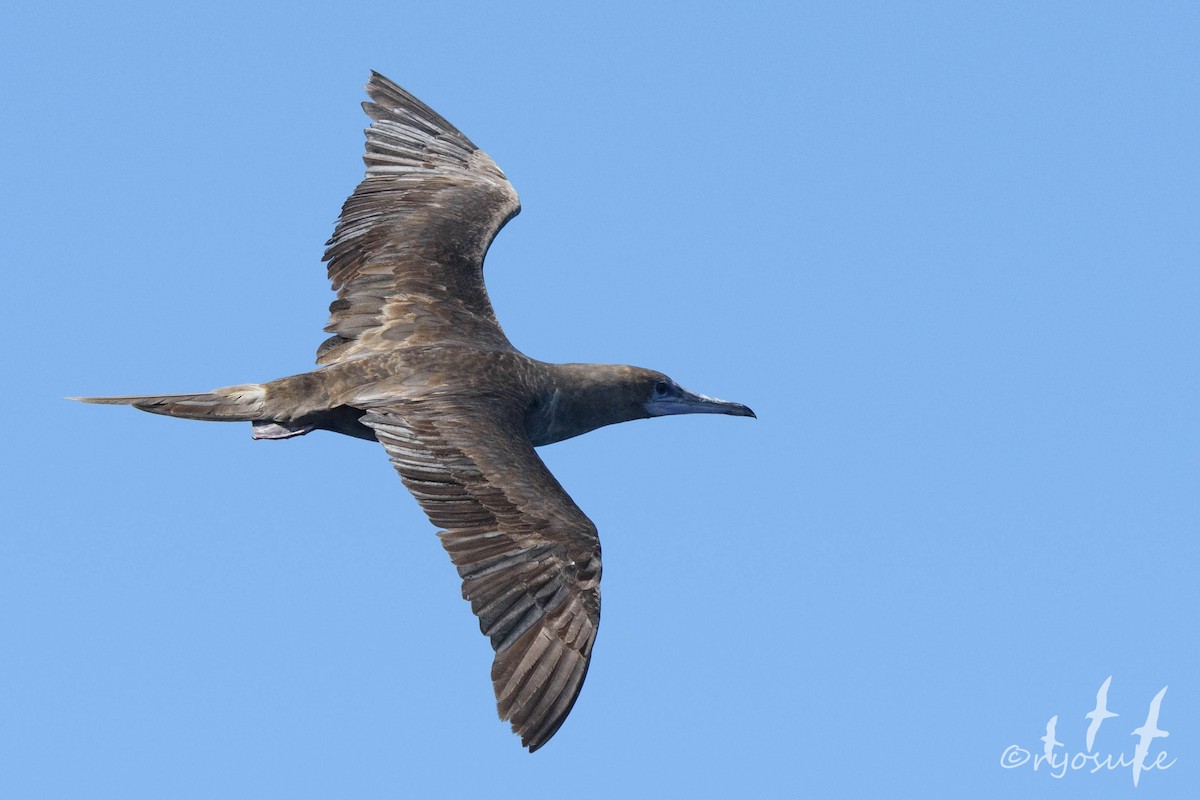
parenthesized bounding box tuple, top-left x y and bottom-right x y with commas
(362, 401, 601, 752)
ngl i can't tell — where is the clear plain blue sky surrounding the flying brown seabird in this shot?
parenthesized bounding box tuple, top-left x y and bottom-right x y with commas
(0, 2, 1200, 800)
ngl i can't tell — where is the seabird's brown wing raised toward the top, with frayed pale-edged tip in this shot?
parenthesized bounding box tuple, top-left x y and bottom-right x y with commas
(317, 72, 521, 365)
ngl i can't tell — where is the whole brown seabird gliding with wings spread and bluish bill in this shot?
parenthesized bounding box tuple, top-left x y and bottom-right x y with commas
(76, 73, 754, 752)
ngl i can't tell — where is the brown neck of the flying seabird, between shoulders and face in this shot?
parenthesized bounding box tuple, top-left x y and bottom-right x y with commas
(526, 363, 649, 446)
